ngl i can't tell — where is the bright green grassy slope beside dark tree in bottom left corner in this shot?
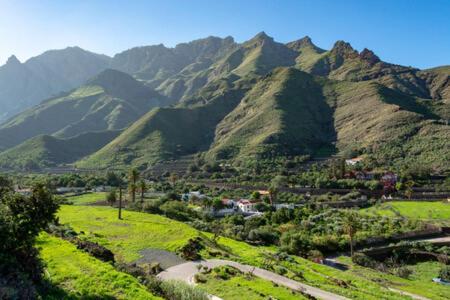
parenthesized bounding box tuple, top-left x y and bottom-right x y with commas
(37, 233, 160, 300)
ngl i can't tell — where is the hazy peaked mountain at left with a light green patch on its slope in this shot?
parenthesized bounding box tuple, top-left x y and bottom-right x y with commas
(0, 69, 169, 149)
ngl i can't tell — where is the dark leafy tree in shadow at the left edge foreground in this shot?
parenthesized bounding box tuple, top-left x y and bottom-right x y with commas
(0, 182, 58, 299)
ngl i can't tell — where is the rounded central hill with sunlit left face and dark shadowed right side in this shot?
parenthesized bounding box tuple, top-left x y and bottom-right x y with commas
(208, 68, 335, 160)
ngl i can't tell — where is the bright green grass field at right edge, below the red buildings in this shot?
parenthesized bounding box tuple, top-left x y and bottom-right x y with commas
(366, 201, 450, 225)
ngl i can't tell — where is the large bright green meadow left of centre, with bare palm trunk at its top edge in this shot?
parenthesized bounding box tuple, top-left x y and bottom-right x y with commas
(58, 206, 199, 262)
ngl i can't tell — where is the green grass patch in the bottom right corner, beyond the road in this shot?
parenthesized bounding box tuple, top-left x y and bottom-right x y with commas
(339, 257, 450, 300)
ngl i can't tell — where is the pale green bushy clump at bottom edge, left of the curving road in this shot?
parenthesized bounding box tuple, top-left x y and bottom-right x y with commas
(161, 280, 209, 300)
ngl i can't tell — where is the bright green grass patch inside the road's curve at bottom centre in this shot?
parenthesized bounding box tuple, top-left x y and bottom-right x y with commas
(197, 267, 307, 300)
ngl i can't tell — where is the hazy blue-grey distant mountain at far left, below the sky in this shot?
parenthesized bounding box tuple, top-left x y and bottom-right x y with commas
(0, 47, 110, 122)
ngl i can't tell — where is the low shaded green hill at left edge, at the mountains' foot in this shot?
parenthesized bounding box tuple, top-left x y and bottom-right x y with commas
(0, 130, 120, 169)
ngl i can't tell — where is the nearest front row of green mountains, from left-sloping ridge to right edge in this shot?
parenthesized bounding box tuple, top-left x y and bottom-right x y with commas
(78, 63, 450, 169)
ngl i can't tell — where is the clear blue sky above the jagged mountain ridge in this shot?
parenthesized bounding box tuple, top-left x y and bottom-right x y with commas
(0, 0, 450, 68)
